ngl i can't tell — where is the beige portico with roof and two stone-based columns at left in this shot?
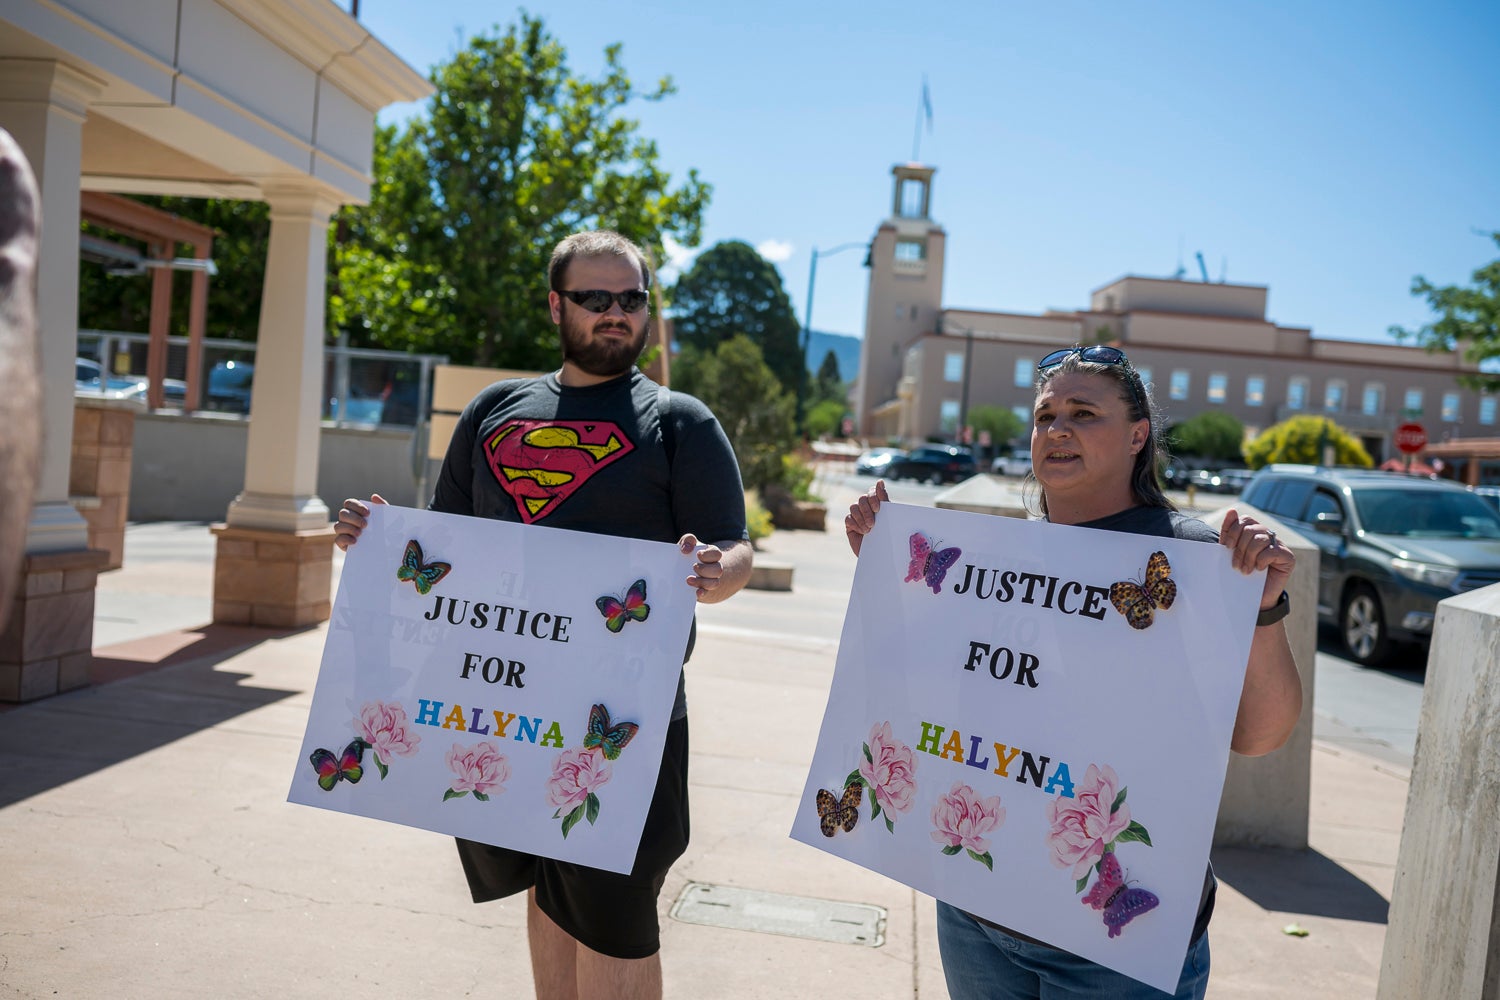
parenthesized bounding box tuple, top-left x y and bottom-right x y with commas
(0, 0, 431, 702)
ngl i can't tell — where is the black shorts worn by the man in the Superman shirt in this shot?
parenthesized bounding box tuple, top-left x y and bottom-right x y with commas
(458, 718, 689, 958)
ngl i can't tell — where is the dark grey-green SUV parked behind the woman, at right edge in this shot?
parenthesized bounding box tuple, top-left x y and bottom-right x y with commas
(1244, 465, 1500, 666)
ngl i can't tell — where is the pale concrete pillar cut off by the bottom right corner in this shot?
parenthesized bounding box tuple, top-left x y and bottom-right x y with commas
(1377, 585, 1500, 1000)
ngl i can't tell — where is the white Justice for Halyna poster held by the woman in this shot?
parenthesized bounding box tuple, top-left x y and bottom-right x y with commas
(792, 502, 1265, 991)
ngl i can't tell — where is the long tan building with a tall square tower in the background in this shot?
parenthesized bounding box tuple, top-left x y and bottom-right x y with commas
(854, 165, 1500, 481)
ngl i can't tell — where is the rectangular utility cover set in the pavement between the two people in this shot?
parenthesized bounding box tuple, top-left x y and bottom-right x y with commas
(672, 882, 885, 948)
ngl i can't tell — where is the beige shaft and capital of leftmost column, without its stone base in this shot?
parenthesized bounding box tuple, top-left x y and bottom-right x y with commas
(0, 58, 104, 553)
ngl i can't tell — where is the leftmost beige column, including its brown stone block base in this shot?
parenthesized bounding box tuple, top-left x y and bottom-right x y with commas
(0, 58, 107, 702)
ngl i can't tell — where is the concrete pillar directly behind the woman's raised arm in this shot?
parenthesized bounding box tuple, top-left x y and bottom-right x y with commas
(1203, 502, 1320, 850)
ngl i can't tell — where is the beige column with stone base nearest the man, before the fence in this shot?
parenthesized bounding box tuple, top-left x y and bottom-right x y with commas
(213, 184, 338, 627)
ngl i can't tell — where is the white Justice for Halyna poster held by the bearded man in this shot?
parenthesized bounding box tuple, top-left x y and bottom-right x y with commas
(287, 505, 696, 873)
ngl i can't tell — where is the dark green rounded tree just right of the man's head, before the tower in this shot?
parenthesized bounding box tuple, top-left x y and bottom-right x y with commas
(672, 240, 807, 394)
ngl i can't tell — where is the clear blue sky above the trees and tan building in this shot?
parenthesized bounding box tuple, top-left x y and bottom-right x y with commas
(354, 0, 1500, 342)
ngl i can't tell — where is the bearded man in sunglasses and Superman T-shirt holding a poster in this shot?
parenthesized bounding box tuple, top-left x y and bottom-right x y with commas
(335, 231, 752, 1000)
